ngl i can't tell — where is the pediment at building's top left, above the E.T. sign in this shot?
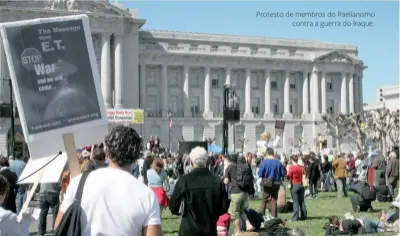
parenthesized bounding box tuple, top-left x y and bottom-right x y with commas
(0, 0, 132, 18)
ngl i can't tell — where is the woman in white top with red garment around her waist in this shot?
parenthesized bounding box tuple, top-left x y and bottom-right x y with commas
(147, 159, 169, 213)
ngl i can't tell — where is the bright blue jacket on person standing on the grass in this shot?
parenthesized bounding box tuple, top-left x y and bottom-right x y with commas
(258, 159, 286, 181)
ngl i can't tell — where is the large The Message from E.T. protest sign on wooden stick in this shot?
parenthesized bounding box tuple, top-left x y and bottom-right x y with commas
(0, 15, 108, 216)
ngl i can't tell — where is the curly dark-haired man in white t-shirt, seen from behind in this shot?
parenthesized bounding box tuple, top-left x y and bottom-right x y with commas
(55, 126, 163, 236)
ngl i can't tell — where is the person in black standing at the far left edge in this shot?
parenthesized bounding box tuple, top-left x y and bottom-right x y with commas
(0, 157, 18, 213)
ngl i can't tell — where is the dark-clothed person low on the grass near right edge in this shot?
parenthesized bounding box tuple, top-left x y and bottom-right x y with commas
(349, 175, 376, 212)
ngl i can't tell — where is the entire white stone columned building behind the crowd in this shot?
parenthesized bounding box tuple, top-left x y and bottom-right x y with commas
(0, 0, 366, 154)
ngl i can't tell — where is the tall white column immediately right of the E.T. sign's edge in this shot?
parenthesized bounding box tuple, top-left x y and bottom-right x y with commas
(100, 33, 112, 108)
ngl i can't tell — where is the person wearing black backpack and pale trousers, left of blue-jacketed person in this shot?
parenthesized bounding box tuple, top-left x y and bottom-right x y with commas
(224, 154, 255, 235)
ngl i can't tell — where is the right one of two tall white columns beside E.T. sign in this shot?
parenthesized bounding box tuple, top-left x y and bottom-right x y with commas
(114, 35, 124, 108)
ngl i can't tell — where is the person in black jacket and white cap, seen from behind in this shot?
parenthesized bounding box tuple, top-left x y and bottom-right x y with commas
(169, 147, 228, 236)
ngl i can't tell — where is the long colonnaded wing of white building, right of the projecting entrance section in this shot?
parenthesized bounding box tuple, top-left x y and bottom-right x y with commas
(139, 30, 366, 151)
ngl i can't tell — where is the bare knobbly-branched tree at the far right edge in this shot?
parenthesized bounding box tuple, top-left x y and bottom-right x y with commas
(364, 107, 400, 152)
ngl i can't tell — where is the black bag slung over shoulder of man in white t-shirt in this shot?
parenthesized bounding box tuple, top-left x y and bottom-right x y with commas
(53, 171, 90, 236)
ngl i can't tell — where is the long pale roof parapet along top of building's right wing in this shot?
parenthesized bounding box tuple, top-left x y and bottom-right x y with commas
(140, 30, 357, 52)
